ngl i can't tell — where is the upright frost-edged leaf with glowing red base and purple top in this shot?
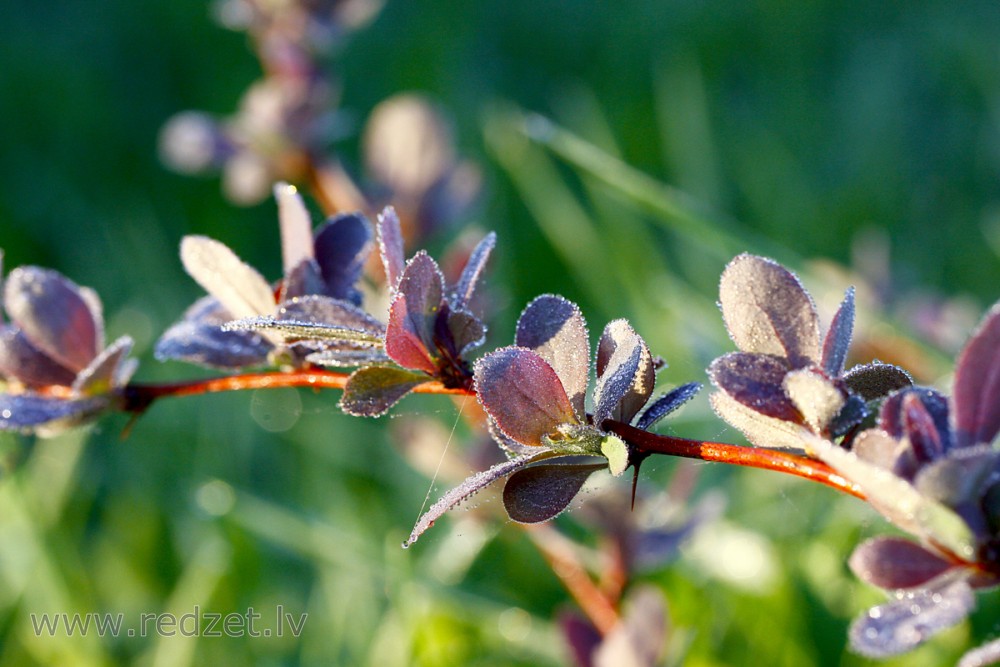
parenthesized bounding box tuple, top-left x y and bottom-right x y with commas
(385, 251, 444, 375)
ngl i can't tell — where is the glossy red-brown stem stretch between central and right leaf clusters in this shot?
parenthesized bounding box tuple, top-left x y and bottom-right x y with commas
(604, 421, 865, 500)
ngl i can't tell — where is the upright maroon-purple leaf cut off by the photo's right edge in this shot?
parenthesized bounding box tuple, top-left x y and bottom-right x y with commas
(953, 304, 1000, 447)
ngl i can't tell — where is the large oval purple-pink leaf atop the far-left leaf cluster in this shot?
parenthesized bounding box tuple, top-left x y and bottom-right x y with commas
(4, 266, 104, 372)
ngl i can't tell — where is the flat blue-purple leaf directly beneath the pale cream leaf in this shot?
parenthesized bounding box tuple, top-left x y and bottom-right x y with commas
(155, 296, 274, 368)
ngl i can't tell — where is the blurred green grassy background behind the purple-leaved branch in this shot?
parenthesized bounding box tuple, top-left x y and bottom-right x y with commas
(0, 0, 1000, 666)
